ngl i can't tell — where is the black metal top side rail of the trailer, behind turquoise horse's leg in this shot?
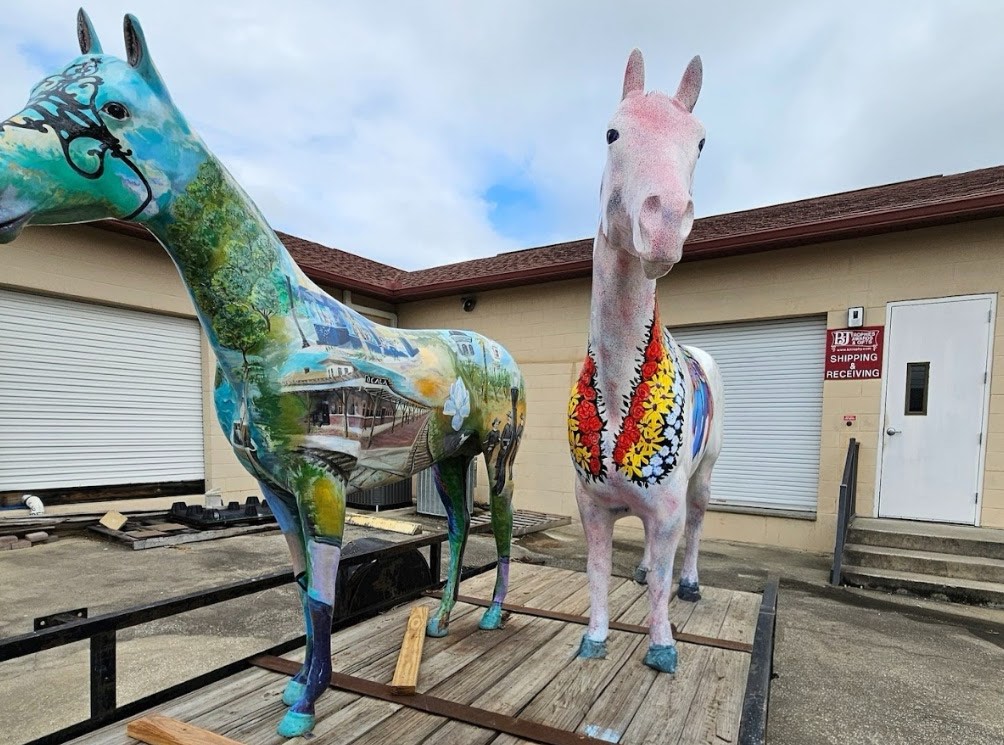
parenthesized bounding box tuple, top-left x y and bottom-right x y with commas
(0, 533, 447, 662)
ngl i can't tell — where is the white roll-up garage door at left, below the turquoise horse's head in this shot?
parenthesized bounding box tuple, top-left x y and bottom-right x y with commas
(0, 290, 205, 491)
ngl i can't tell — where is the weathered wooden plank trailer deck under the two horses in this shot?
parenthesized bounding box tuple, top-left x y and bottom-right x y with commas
(73, 564, 772, 745)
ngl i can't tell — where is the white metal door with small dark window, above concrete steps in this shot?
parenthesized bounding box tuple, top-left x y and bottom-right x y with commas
(879, 296, 994, 525)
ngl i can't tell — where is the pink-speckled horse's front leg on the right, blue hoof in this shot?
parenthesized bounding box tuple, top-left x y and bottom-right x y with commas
(642, 490, 686, 673)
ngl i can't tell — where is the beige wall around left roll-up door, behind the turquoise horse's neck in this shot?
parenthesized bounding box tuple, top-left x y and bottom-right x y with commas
(0, 227, 260, 499)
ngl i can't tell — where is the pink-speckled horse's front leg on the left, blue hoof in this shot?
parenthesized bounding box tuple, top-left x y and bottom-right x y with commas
(575, 487, 613, 660)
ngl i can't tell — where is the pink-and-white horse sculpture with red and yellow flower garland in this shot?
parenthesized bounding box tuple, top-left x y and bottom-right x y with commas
(568, 49, 723, 673)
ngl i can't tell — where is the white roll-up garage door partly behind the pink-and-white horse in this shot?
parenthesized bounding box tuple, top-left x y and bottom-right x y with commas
(670, 316, 826, 512)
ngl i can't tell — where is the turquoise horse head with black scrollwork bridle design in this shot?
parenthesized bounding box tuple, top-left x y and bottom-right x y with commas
(0, 10, 205, 243)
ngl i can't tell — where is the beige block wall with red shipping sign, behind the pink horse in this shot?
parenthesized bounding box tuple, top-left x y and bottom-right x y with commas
(399, 219, 1004, 551)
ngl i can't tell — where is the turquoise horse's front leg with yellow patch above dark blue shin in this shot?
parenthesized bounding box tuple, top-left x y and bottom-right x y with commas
(278, 462, 345, 737)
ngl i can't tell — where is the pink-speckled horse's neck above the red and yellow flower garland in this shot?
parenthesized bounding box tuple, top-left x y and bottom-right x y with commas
(589, 231, 658, 422)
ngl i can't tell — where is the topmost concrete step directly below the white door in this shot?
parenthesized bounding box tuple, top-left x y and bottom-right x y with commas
(847, 517, 1004, 560)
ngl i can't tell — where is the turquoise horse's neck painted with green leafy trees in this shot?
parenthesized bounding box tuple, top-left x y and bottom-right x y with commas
(146, 154, 316, 378)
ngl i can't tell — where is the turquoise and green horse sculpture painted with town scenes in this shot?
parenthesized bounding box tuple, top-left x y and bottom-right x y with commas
(0, 10, 526, 736)
